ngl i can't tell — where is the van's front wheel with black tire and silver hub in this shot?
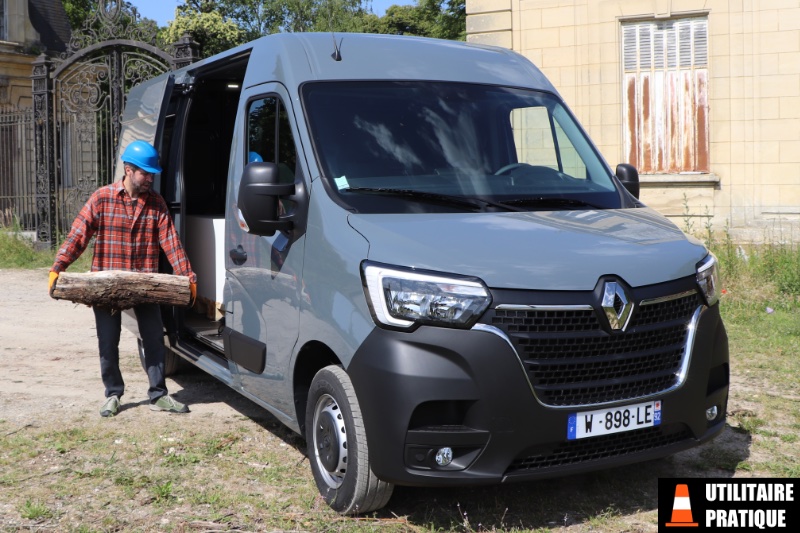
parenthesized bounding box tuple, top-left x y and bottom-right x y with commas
(306, 366, 394, 515)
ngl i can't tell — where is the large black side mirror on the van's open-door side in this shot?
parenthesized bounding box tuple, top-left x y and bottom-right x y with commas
(237, 162, 295, 237)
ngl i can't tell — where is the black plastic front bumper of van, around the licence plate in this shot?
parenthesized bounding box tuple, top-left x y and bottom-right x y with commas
(347, 306, 729, 486)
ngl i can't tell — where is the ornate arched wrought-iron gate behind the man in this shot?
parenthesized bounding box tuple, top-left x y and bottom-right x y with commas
(32, 0, 197, 243)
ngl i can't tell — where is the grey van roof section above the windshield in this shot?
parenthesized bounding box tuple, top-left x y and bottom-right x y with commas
(183, 33, 556, 92)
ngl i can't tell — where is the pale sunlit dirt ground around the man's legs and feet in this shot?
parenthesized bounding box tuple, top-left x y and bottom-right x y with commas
(0, 270, 242, 425)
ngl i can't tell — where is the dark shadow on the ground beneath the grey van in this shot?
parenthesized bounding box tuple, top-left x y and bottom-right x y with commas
(173, 370, 751, 531)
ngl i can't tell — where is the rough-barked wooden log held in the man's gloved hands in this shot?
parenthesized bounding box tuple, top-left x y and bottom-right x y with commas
(50, 270, 192, 310)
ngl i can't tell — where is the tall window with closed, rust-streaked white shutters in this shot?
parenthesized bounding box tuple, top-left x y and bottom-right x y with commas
(622, 17, 709, 173)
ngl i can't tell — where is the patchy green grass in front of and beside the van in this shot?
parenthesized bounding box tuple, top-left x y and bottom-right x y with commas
(0, 221, 800, 533)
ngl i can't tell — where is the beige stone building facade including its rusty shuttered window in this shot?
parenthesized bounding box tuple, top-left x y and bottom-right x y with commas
(467, 0, 800, 243)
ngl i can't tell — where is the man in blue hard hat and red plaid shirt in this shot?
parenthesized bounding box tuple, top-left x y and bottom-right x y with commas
(50, 141, 197, 417)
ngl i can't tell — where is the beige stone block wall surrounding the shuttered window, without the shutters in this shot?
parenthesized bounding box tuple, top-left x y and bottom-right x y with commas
(467, 0, 800, 242)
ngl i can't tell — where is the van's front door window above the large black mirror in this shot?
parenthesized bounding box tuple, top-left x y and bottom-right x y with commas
(247, 96, 297, 183)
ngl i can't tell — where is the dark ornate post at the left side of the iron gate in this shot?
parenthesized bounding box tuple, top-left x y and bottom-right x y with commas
(31, 54, 58, 248)
